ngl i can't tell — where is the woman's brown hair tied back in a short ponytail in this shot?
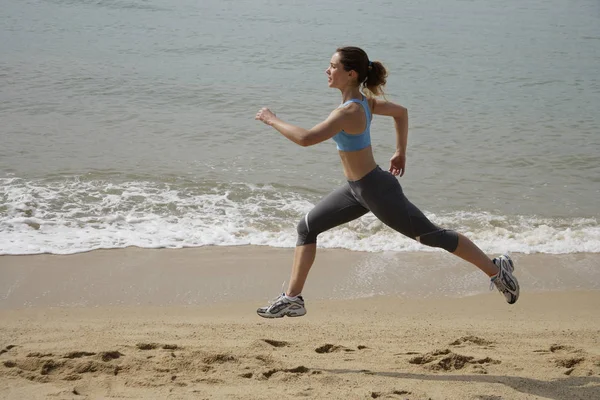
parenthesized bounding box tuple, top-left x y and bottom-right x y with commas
(336, 46, 387, 96)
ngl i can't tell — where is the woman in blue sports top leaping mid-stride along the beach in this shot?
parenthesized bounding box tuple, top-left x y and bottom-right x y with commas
(255, 47, 519, 318)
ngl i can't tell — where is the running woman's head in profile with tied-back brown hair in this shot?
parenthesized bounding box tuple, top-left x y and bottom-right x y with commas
(326, 46, 387, 96)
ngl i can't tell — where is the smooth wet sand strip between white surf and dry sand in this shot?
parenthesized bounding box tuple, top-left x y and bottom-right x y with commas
(0, 246, 600, 310)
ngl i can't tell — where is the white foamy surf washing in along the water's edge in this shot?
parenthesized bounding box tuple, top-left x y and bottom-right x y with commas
(0, 178, 600, 254)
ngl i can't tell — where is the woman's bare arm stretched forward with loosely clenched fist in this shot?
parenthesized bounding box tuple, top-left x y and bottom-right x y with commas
(254, 108, 344, 147)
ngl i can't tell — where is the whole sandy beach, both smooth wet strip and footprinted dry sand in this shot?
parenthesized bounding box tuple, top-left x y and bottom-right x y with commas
(0, 246, 600, 400)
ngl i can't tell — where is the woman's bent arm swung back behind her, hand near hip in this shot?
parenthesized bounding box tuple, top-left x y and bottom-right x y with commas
(371, 99, 408, 176)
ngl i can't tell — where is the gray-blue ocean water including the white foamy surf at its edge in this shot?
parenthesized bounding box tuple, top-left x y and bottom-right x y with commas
(0, 0, 600, 254)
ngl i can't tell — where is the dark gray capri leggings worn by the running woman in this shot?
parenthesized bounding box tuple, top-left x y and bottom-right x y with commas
(296, 167, 458, 253)
